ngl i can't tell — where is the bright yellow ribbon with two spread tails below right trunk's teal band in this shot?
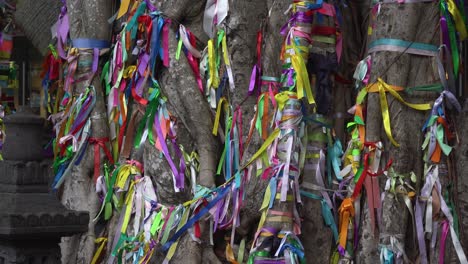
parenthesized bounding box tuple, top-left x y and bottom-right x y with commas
(367, 78, 431, 147)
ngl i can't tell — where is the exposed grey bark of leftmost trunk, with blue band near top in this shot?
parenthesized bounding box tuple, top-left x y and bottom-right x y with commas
(61, 0, 111, 263)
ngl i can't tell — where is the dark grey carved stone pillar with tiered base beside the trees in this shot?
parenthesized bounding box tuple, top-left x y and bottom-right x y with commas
(0, 106, 89, 264)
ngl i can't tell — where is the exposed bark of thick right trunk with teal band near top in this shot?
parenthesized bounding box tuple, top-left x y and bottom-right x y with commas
(358, 3, 438, 263)
